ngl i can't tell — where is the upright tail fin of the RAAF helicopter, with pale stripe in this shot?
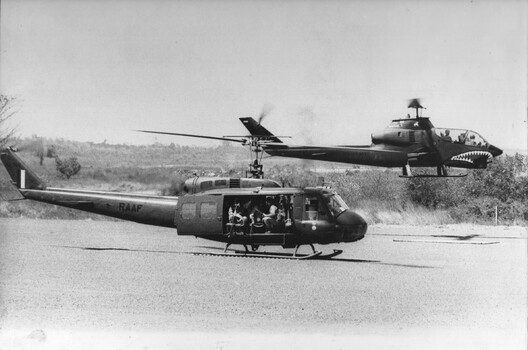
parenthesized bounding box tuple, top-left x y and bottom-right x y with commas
(0, 148, 46, 190)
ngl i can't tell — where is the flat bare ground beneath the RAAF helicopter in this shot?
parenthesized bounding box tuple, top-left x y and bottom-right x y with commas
(0, 219, 527, 349)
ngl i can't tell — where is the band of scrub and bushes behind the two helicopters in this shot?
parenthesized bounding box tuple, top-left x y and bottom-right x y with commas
(0, 95, 528, 224)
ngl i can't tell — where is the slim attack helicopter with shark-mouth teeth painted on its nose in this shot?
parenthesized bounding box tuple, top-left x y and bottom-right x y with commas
(139, 99, 502, 178)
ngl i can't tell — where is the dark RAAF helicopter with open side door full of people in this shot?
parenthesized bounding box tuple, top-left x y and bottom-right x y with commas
(0, 147, 367, 260)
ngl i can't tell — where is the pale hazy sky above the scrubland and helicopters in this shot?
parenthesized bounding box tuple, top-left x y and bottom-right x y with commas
(0, 0, 528, 149)
